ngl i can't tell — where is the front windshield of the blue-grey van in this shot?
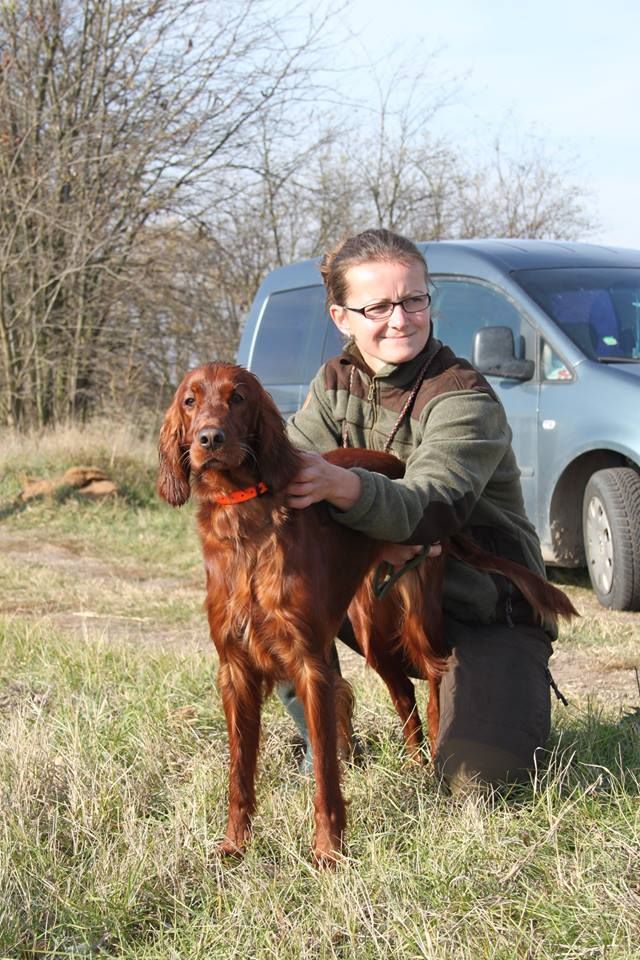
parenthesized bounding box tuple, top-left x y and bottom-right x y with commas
(513, 267, 640, 363)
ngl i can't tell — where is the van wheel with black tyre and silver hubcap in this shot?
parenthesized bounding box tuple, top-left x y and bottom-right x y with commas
(582, 467, 640, 610)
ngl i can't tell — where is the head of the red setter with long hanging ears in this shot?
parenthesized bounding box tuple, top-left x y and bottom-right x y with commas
(158, 363, 288, 507)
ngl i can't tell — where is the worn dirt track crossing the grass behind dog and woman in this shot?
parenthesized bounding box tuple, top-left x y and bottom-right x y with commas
(0, 529, 640, 709)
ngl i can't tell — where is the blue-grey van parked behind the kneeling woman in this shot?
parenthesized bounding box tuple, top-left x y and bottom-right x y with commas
(238, 240, 640, 610)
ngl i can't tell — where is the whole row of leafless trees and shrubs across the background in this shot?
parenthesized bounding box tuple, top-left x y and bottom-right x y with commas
(0, 8, 589, 425)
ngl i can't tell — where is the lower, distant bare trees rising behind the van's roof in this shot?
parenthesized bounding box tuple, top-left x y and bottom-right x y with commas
(210, 60, 593, 286)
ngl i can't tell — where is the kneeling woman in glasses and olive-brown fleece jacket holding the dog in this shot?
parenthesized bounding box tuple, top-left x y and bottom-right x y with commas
(279, 230, 554, 791)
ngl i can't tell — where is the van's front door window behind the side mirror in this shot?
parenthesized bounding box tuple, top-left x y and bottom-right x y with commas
(431, 278, 523, 360)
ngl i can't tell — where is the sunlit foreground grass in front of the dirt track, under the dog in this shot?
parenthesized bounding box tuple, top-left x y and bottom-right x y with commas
(0, 620, 640, 960)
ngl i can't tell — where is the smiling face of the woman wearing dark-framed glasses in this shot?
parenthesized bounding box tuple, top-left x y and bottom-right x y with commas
(330, 260, 431, 373)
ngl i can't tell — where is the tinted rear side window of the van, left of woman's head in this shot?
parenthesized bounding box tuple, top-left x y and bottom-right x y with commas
(251, 286, 324, 384)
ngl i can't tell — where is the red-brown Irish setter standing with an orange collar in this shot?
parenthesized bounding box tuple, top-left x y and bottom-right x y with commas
(158, 363, 575, 865)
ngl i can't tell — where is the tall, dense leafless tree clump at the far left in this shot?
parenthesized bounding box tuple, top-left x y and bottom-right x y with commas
(0, 0, 338, 424)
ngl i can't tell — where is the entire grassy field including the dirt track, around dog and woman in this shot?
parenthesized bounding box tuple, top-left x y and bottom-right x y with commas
(0, 428, 640, 960)
